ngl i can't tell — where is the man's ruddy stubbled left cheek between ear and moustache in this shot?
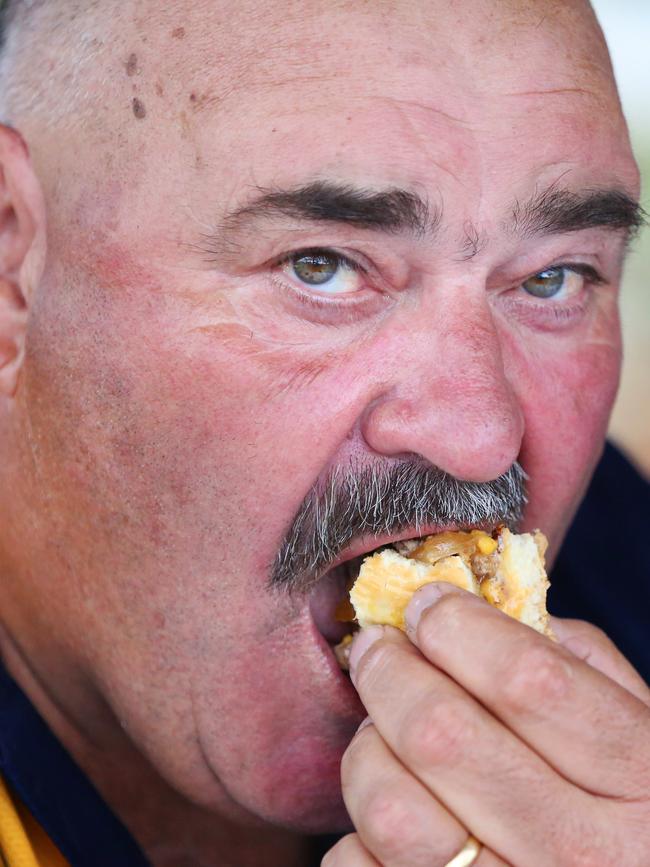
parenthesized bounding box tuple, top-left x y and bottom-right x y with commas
(21, 262, 364, 611)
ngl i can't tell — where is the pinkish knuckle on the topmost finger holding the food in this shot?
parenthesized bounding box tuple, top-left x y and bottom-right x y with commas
(499, 643, 573, 714)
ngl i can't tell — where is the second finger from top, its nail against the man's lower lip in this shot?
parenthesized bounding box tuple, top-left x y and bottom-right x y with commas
(350, 627, 584, 867)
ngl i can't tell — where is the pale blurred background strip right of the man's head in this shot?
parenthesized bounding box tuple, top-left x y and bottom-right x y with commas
(592, 0, 650, 479)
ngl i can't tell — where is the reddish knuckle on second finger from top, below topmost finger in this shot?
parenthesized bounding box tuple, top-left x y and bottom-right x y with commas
(400, 695, 476, 768)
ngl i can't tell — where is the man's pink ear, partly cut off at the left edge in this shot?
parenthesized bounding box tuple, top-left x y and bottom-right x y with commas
(0, 124, 46, 398)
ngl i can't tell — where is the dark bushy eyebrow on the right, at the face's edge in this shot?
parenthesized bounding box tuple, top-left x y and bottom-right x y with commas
(513, 187, 647, 237)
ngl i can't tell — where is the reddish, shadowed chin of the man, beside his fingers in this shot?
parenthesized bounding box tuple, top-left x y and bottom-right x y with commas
(194, 680, 365, 834)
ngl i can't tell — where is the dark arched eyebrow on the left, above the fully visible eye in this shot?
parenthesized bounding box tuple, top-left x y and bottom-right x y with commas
(222, 181, 441, 235)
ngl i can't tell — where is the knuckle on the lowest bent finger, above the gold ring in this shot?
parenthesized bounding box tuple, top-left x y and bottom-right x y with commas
(359, 786, 420, 861)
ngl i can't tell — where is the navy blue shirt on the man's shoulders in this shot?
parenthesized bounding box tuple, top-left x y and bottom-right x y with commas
(0, 446, 650, 867)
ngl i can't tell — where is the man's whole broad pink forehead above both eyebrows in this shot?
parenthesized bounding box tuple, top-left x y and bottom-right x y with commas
(53, 0, 634, 241)
